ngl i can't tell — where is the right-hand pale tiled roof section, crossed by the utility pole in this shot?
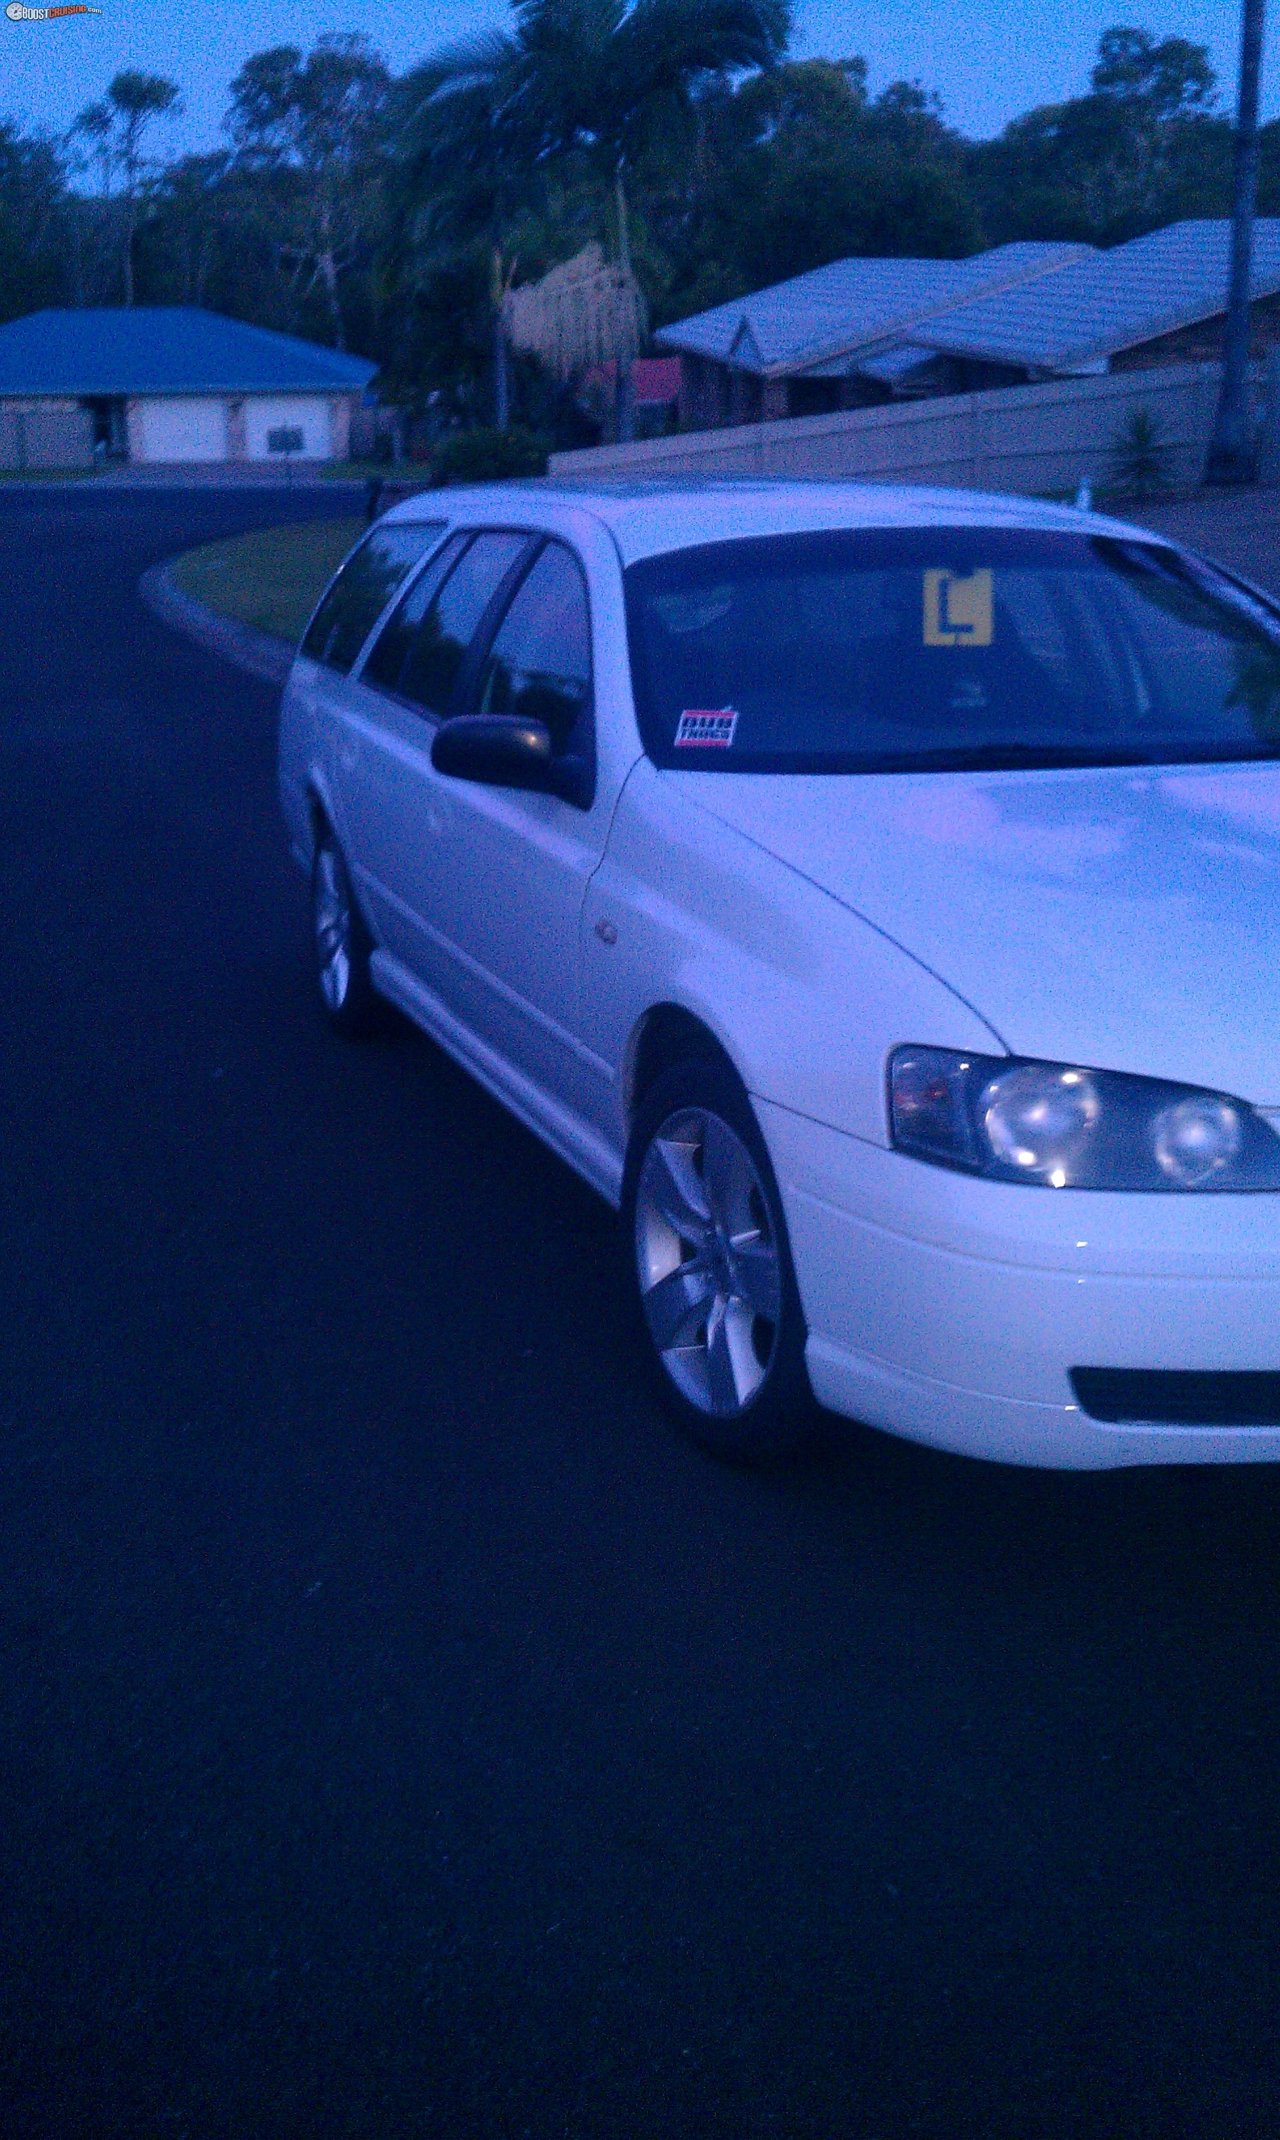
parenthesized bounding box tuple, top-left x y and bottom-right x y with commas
(912, 216, 1280, 370)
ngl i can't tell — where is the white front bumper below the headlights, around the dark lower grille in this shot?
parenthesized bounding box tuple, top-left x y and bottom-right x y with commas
(756, 1100, 1280, 1470)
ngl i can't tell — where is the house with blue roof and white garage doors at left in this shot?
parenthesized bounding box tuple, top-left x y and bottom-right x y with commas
(0, 306, 377, 467)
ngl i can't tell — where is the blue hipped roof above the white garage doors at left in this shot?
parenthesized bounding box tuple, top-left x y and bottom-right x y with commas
(0, 304, 377, 396)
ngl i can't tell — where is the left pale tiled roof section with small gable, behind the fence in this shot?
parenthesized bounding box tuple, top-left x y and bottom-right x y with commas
(655, 242, 1092, 372)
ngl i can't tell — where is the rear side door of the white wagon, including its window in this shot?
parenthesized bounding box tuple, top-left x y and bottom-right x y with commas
(336, 529, 531, 993)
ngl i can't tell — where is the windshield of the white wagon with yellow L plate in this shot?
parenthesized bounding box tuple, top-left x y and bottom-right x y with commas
(627, 526, 1280, 773)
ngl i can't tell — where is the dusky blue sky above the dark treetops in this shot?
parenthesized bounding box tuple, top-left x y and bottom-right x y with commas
(0, 0, 1280, 154)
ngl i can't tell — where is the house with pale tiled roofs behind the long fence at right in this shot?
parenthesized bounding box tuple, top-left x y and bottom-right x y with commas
(655, 218, 1280, 430)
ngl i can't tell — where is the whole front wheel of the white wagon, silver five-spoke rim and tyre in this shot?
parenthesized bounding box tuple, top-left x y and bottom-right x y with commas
(623, 1057, 816, 1464)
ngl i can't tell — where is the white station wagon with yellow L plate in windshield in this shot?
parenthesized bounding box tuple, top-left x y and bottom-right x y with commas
(280, 482, 1280, 1466)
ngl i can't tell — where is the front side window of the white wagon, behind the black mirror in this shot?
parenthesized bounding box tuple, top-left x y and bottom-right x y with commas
(471, 541, 591, 758)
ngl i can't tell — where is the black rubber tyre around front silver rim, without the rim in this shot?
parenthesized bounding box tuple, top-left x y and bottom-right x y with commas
(621, 1055, 816, 1464)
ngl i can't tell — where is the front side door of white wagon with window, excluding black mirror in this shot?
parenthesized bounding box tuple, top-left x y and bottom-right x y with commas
(417, 537, 608, 1113)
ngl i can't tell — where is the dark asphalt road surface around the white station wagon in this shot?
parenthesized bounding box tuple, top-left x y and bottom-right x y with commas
(0, 492, 1280, 2140)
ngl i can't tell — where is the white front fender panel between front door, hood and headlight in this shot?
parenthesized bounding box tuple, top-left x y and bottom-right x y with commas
(582, 760, 1002, 1145)
